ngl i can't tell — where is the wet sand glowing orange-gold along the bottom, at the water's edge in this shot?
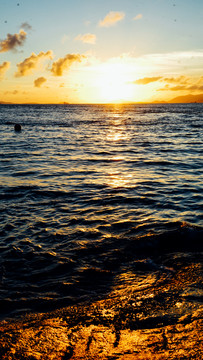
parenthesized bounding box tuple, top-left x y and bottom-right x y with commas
(0, 262, 203, 360)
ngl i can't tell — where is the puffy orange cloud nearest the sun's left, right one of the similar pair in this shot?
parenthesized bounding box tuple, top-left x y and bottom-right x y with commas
(51, 54, 85, 76)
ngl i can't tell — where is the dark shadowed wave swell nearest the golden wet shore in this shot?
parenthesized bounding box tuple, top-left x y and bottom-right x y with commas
(0, 222, 203, 314)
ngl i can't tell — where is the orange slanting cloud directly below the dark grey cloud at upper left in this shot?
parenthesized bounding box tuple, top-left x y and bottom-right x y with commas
(15, 50, 52, 77)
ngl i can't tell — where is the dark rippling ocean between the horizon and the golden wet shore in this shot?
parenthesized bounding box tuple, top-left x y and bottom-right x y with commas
(0, 104, 203, 319)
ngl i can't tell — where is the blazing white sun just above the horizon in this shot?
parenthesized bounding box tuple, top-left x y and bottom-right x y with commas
(96, 63, 134, 103)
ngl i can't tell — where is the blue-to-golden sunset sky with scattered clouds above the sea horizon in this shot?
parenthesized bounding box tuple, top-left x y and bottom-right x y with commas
(0, 0, 203, 103)
